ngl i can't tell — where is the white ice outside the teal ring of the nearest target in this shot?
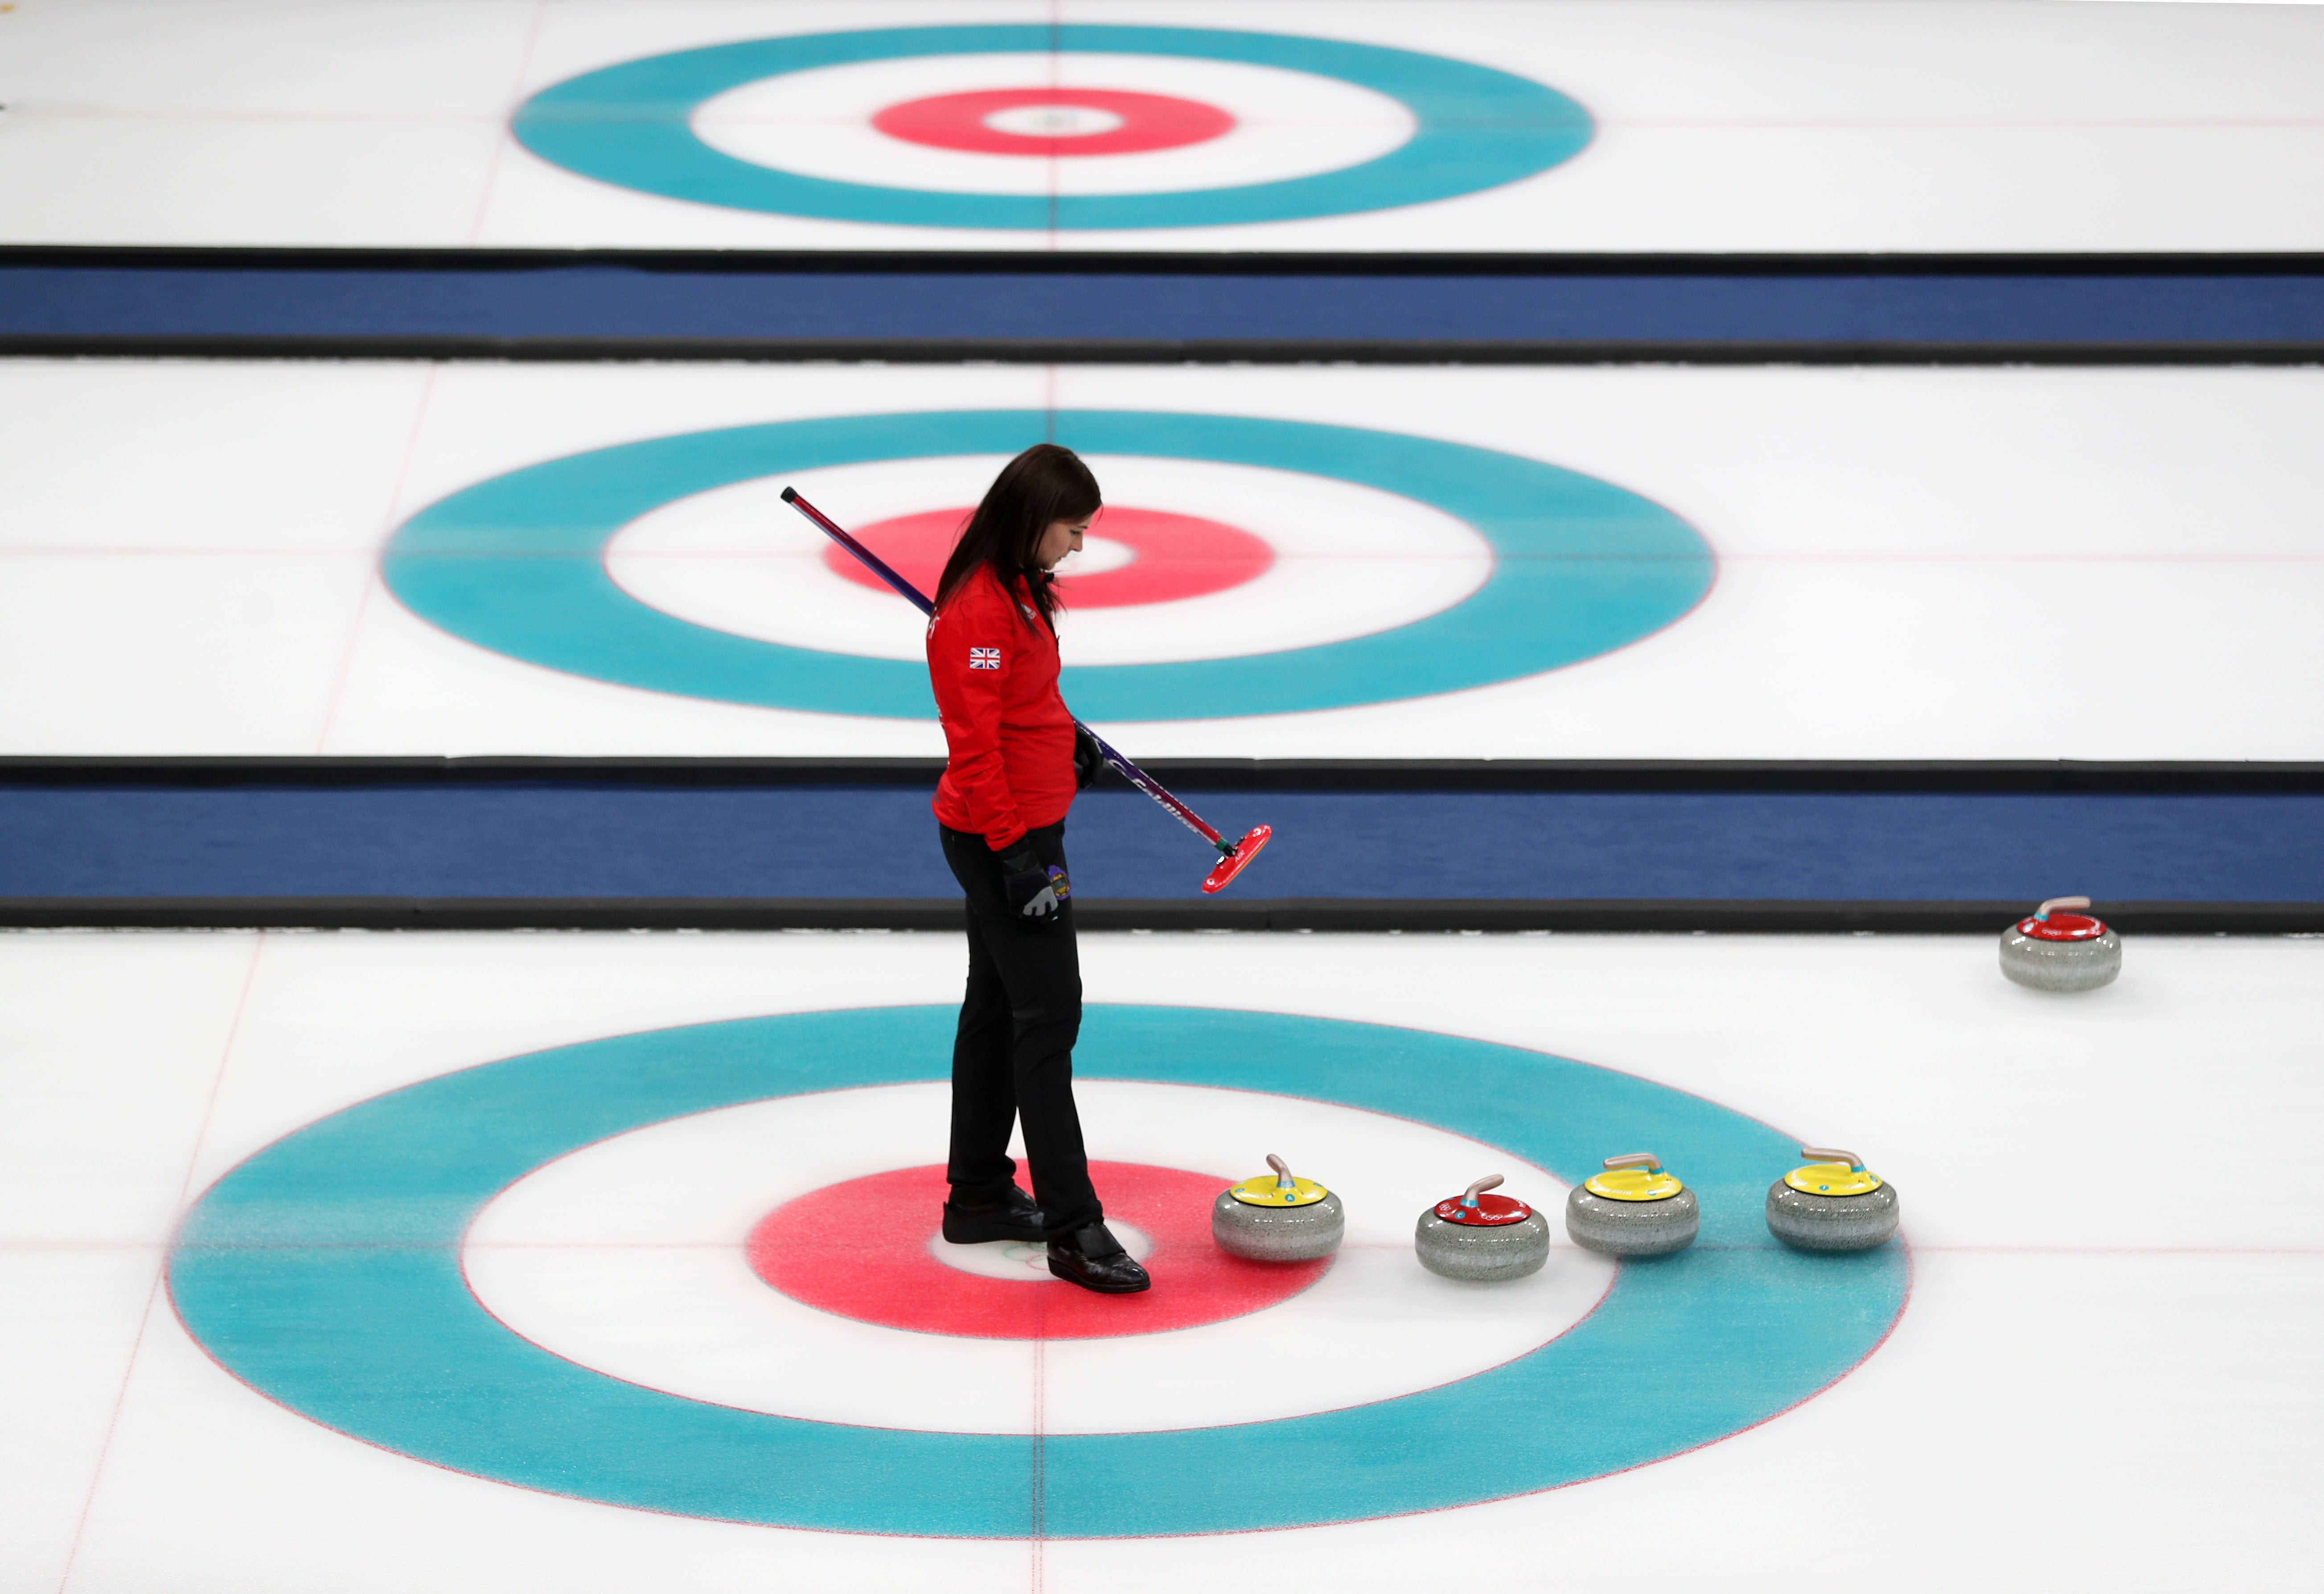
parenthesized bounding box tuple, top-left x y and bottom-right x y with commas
(0, 934, 2324, 1594)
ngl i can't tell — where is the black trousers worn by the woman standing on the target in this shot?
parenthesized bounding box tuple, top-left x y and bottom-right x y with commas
(939, 822, 1104, 1236)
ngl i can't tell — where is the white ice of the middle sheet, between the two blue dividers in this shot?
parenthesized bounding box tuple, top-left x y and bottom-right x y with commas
(0, 360, 2324, 760)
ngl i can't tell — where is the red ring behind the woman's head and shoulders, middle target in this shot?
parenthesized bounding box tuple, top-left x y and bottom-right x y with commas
(823, 504, 1276, 609)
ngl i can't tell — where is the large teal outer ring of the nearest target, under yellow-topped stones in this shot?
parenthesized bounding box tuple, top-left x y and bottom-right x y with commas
(170, 1006, 1908, 1538)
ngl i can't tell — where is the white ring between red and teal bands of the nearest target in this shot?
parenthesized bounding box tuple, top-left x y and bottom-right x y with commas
(463, 1080, 1613, 1434)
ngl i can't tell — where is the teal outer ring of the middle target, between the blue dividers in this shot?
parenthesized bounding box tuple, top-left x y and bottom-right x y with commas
(383, 409, 1715, 723)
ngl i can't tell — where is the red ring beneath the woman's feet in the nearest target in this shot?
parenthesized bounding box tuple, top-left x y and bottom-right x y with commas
(746, 1162, 1332, 1339)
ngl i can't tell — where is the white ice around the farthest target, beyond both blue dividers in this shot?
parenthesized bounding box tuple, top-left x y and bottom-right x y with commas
(0, 0, 2324, 251)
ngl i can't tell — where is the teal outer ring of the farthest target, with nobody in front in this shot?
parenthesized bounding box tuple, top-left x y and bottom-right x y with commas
(513, 23, 1592, 232)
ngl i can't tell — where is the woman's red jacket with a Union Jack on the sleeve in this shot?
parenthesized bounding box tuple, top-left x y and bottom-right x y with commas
(927, 565, 1074, 853)
